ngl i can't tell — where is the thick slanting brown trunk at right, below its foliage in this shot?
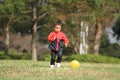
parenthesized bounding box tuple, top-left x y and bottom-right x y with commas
(93, 21, 103, 55)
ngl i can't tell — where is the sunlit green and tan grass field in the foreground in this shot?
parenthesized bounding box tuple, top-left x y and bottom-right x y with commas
(0, 60, 120, 80)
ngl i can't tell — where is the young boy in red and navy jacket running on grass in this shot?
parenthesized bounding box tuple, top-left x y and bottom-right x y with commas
(48, 23, 68, 68)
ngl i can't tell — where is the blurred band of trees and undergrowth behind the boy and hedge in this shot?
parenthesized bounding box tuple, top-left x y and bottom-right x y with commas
(0, 0, 120, 62)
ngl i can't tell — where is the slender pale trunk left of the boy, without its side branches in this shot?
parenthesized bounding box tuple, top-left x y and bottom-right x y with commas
(31, 0, 37, 61)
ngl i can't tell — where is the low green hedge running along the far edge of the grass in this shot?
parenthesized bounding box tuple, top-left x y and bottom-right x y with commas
(0, 52, 120, 63)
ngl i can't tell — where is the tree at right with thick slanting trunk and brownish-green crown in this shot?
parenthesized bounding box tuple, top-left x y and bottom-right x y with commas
(87, 0, 120, 55)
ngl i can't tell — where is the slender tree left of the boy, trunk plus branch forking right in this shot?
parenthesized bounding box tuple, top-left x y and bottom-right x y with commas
(31, 0, 47, 61)
